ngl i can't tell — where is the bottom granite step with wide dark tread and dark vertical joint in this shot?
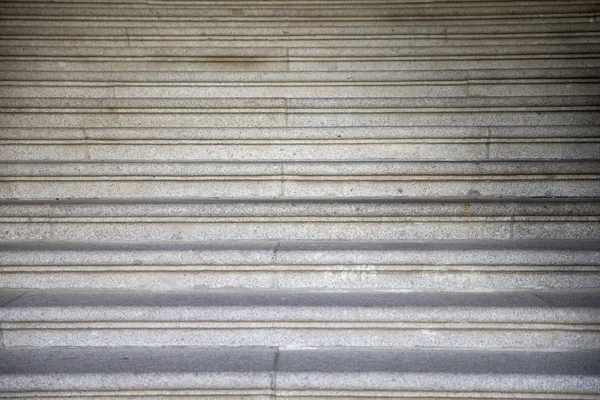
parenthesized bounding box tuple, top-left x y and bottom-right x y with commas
(0, 348, 600, 399)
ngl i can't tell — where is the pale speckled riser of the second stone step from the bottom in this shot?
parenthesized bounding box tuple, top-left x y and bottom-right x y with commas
(2, 324, 600, 350)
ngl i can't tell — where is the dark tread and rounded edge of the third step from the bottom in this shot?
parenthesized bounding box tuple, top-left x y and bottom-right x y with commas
(0, 240, 600, 266)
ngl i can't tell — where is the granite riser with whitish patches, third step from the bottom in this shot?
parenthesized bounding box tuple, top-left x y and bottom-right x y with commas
(1, 265, 600, 291)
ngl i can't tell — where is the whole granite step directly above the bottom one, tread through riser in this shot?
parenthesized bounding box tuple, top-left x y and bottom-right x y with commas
(0, 291, 600, 350)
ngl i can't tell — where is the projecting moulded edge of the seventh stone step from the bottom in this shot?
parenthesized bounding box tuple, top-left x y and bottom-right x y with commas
(0, 94, 600, 105)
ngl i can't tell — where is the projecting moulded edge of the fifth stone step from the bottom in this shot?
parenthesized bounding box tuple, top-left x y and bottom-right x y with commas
(0, 159, 600, 177)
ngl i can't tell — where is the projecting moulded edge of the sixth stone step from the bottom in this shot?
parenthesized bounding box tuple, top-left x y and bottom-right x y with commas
(0, 125, 598, 141)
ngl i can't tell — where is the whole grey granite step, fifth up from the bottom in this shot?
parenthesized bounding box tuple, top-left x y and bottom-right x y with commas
(0, 160, 600, 201)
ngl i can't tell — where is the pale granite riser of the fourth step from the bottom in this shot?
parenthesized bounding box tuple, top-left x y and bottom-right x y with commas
(0, 218, 600, 241)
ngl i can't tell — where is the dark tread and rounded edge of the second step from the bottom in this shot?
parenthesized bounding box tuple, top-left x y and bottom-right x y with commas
(0, 290, 600, 316)
